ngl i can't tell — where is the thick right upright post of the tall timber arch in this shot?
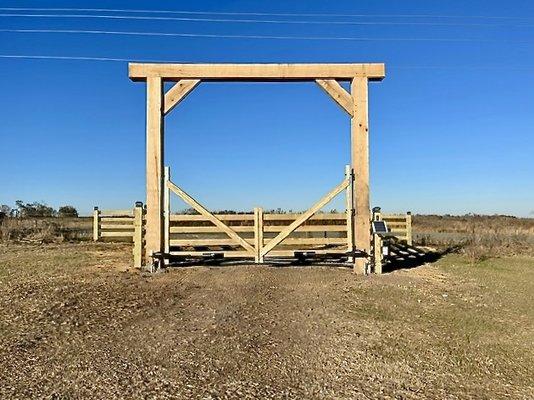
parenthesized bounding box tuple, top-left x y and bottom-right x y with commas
(350, 77, 371, 274)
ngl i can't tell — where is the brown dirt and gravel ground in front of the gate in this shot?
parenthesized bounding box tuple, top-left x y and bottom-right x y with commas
(0, 244, 534, 399)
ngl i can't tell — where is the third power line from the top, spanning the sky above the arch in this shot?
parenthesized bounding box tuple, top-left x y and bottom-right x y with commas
(0, 29, 534, 43)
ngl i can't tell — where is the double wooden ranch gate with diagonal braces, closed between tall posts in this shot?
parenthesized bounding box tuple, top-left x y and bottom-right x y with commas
(164, 166, 357, 263)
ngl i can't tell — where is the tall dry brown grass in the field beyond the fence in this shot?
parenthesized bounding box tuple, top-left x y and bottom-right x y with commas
(0, 215, 534, 263)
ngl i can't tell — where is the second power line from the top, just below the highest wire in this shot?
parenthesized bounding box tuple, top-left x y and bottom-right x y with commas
(0, 14, 533, 28)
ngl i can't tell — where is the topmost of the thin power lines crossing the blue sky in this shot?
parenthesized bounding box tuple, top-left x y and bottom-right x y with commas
(0, 7, 532, 21)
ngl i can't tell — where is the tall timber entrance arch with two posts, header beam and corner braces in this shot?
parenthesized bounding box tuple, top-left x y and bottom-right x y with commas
(129, 63, 385, 273)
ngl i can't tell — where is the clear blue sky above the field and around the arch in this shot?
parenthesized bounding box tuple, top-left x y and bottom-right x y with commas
(0, 0, 534, 216)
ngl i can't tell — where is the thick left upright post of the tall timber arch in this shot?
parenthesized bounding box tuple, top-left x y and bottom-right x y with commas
(146, 77, 165, 257)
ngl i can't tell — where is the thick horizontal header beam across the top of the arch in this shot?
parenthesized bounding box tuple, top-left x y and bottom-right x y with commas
(132, 63, 385, 81)
